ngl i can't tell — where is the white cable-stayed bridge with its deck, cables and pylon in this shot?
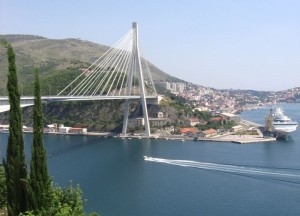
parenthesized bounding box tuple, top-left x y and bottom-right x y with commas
(0, 23, 158, 136)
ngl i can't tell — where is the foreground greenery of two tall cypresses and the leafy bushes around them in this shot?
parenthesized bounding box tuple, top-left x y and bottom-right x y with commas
(0, 43, 98, 216)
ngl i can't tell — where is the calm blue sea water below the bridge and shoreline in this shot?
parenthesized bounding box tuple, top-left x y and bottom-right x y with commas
(0, 104, 300, 216)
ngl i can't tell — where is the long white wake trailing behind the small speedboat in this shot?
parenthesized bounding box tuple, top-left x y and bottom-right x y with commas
(144, 156, 300, 184)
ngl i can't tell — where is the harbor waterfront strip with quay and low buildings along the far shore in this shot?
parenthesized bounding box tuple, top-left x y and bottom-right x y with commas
(0, 105, 297, 144)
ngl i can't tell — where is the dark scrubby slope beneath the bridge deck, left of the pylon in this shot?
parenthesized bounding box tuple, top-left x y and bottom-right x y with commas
(41, 100, 124, 132)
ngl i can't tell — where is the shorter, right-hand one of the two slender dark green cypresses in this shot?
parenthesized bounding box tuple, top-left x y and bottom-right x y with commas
(30, 69, 51, 210)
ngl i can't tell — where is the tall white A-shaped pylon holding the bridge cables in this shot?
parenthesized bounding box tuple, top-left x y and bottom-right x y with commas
(122, 22, 151, 137)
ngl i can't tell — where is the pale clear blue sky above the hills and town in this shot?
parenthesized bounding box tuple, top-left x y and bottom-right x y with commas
(0, 0, 300, 91)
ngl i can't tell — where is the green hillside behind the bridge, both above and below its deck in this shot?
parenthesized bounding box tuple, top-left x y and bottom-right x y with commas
(0, 35, 185, 132)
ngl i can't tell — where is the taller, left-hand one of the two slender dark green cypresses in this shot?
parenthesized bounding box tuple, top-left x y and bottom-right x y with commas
(4, 43, 28, 216)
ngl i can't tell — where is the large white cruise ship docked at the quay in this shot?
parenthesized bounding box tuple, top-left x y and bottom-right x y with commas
(266, 107, 298, 139)
